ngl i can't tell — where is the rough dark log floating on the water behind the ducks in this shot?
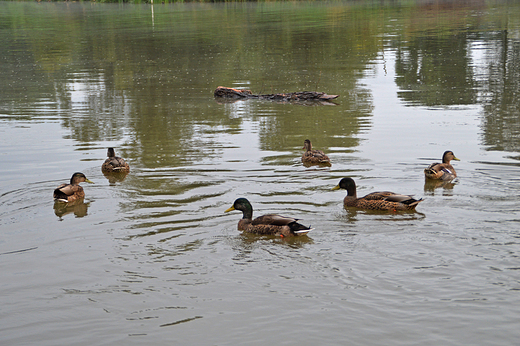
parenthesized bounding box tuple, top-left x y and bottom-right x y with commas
(214, 86, 339, 102)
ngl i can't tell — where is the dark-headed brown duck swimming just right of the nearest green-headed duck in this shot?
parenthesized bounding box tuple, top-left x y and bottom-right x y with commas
(332, 178, 422, 211)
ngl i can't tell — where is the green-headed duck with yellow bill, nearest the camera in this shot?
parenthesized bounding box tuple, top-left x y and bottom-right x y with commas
(225, 198, 312, 238)
